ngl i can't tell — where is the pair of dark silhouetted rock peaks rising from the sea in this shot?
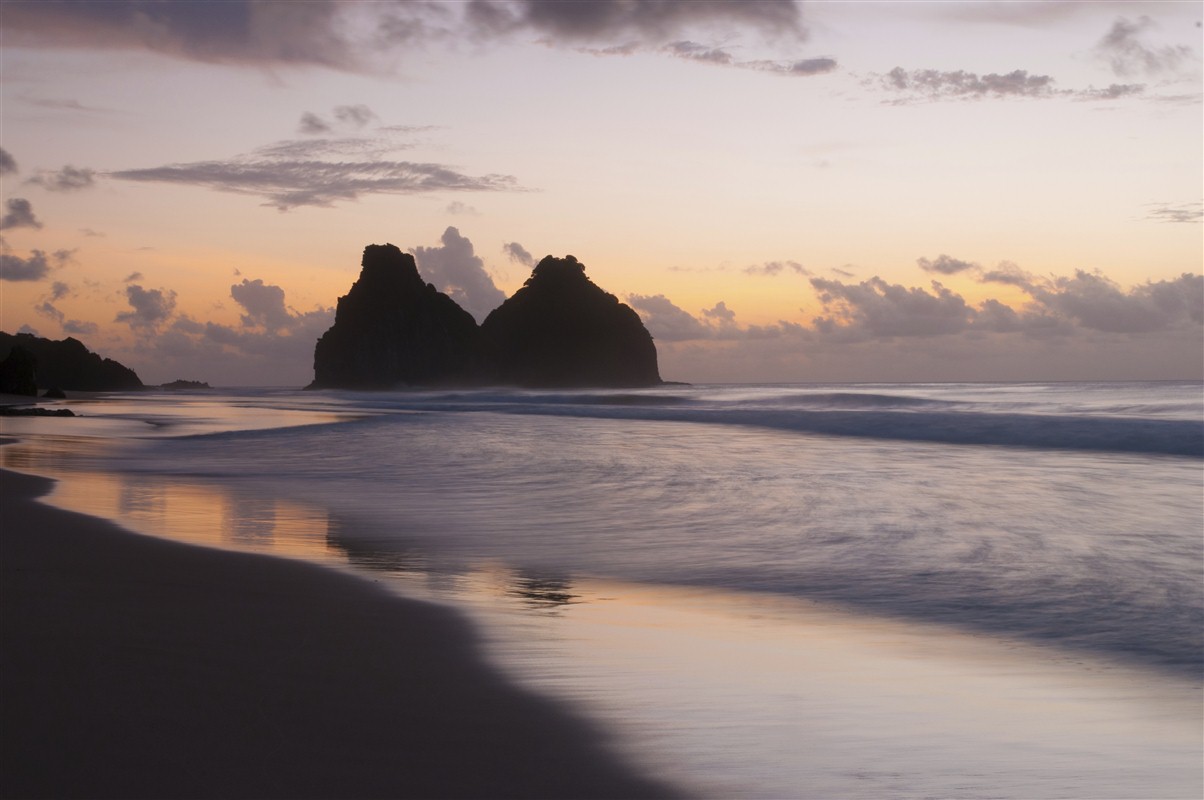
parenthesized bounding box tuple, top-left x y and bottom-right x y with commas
(309, 245, 661, 389)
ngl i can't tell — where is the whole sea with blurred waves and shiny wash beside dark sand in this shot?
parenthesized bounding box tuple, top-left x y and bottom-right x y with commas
(0, 382, 1204, 798)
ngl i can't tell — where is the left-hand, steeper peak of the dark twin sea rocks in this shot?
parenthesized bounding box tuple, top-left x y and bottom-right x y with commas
(311, 245, 477, 388)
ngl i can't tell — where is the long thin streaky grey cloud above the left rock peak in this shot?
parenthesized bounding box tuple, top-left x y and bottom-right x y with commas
(110, 155, 519, 211)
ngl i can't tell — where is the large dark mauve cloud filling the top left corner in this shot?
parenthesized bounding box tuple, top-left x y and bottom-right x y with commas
(4, 0, 361, 69)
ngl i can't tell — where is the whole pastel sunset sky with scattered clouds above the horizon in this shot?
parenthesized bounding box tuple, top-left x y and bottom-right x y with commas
(0, 0, 1204, 387)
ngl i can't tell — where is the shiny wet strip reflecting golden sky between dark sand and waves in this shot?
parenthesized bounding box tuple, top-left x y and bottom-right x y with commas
(0, 437, 1204, 798)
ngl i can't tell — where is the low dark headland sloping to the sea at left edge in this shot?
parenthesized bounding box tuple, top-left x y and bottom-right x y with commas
(0, 331, 142, 392)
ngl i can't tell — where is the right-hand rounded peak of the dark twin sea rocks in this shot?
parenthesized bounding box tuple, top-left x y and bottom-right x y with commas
(480, 255, 661, 388)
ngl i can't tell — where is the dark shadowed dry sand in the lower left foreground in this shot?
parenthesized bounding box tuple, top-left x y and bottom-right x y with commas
(0, 471, 673, 798)
